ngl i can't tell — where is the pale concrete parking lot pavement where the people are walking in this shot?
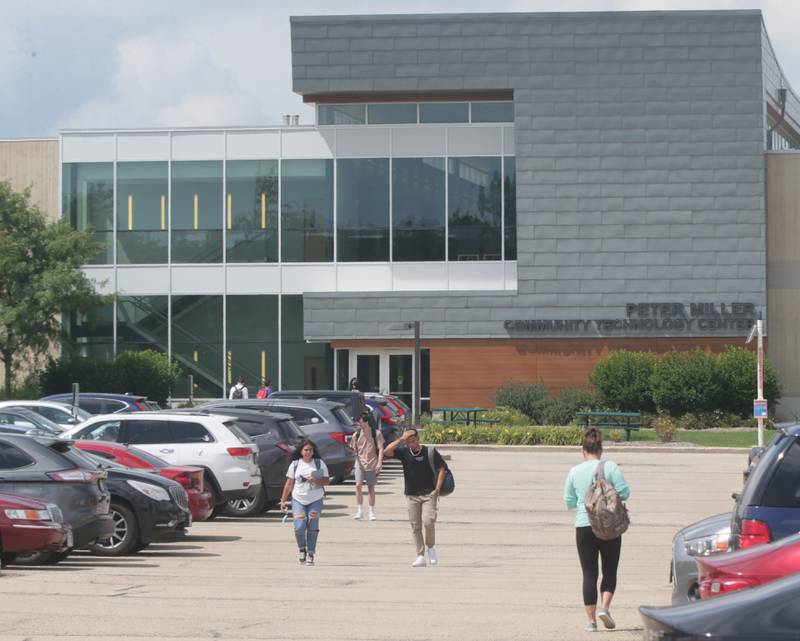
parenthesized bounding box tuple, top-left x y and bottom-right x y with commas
(0, 447, 747, 641)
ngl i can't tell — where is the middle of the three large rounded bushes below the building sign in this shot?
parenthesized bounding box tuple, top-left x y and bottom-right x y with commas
(650, 349, 721, 416)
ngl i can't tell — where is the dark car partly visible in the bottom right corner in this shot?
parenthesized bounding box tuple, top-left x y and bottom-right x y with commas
(639, 574, 800, 641)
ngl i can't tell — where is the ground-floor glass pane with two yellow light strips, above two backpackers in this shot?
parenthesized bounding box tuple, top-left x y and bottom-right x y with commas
(225, 296, 278, 390)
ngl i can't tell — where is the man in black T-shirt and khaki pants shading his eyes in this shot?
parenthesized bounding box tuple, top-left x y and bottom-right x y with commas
(383, 428, 447, 568)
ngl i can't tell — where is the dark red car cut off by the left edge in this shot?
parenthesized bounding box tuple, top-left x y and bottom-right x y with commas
(0, 494, 72, 564)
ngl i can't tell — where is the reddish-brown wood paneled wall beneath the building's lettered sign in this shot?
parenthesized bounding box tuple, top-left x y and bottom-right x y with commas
(333, 338, 753, 407)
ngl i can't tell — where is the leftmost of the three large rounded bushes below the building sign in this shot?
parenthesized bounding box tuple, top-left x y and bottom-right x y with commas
(589, 350, 656, 412)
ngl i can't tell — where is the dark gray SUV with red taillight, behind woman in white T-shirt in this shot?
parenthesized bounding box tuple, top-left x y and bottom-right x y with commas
(195, 394, 356, 483)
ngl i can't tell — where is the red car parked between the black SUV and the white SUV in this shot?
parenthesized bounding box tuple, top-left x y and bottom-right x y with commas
(75, 440, 214, 521)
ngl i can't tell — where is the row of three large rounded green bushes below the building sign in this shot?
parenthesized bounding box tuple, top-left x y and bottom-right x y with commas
(589, 347, 781, 417)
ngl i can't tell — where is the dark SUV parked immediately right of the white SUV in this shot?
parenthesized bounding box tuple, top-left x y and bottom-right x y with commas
(180, 405, 306, 516)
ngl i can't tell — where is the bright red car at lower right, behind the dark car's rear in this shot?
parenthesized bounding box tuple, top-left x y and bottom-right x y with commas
(697, 534, 800, 599)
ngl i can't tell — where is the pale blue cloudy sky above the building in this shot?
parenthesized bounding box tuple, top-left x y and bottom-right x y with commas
(0, 0, 800, 139)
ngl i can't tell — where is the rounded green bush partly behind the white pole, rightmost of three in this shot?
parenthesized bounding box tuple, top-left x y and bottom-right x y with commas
(717, 347, 781, 417)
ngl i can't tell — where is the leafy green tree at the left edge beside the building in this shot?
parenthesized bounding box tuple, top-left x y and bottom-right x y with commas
(0, 181, 103, 398)
